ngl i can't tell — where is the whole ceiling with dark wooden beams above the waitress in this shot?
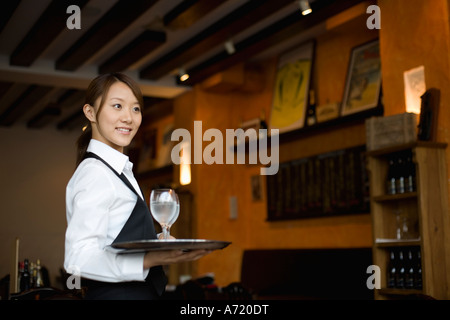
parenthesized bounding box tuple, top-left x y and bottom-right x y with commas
(0, 0, 361, 130)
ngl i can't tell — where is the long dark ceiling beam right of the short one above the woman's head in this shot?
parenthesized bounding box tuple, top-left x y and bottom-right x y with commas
(139, 0, 292, 80)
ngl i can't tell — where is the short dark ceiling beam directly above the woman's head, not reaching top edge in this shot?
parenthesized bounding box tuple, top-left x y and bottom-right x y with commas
(98, 30, 166, 74)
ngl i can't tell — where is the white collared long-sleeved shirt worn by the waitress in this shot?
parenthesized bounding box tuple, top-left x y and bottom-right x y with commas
(64, 139, 148, 282)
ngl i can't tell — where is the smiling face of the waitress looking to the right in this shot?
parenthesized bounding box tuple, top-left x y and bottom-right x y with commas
(88, 81, 142, 152)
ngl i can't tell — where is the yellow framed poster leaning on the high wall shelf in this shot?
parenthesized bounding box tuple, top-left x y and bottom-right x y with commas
(270, 41, 315, 133)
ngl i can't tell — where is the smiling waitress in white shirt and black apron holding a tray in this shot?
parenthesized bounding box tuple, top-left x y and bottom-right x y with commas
(64, 73, 208, 299)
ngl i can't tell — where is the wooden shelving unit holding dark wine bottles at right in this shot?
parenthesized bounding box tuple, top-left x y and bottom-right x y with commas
(367, 142, 450, 299)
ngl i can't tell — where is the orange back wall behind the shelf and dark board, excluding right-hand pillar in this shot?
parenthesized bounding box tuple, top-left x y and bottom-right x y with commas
(179, 15, 378, 285)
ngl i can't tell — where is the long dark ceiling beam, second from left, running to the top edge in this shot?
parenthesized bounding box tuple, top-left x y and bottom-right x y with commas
(55, 0, 157, 71)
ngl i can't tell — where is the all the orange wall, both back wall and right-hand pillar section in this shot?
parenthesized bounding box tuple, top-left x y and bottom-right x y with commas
(163, 0, 450, 285)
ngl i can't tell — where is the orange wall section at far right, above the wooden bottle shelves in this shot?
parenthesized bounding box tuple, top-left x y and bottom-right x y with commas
(378, 0, 450, 207)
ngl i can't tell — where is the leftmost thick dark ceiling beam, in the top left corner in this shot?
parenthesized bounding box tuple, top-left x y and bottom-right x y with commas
(9, 0, 88, 67)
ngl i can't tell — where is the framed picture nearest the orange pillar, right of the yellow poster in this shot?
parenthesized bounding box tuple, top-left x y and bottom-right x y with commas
(341, 40, 381, 116)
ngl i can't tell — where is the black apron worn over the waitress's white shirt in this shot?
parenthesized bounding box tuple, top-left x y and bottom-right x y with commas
(81, 152, 167, 300)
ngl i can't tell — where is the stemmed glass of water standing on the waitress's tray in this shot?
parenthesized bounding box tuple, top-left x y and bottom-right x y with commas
(150, 189, 178, 239)
